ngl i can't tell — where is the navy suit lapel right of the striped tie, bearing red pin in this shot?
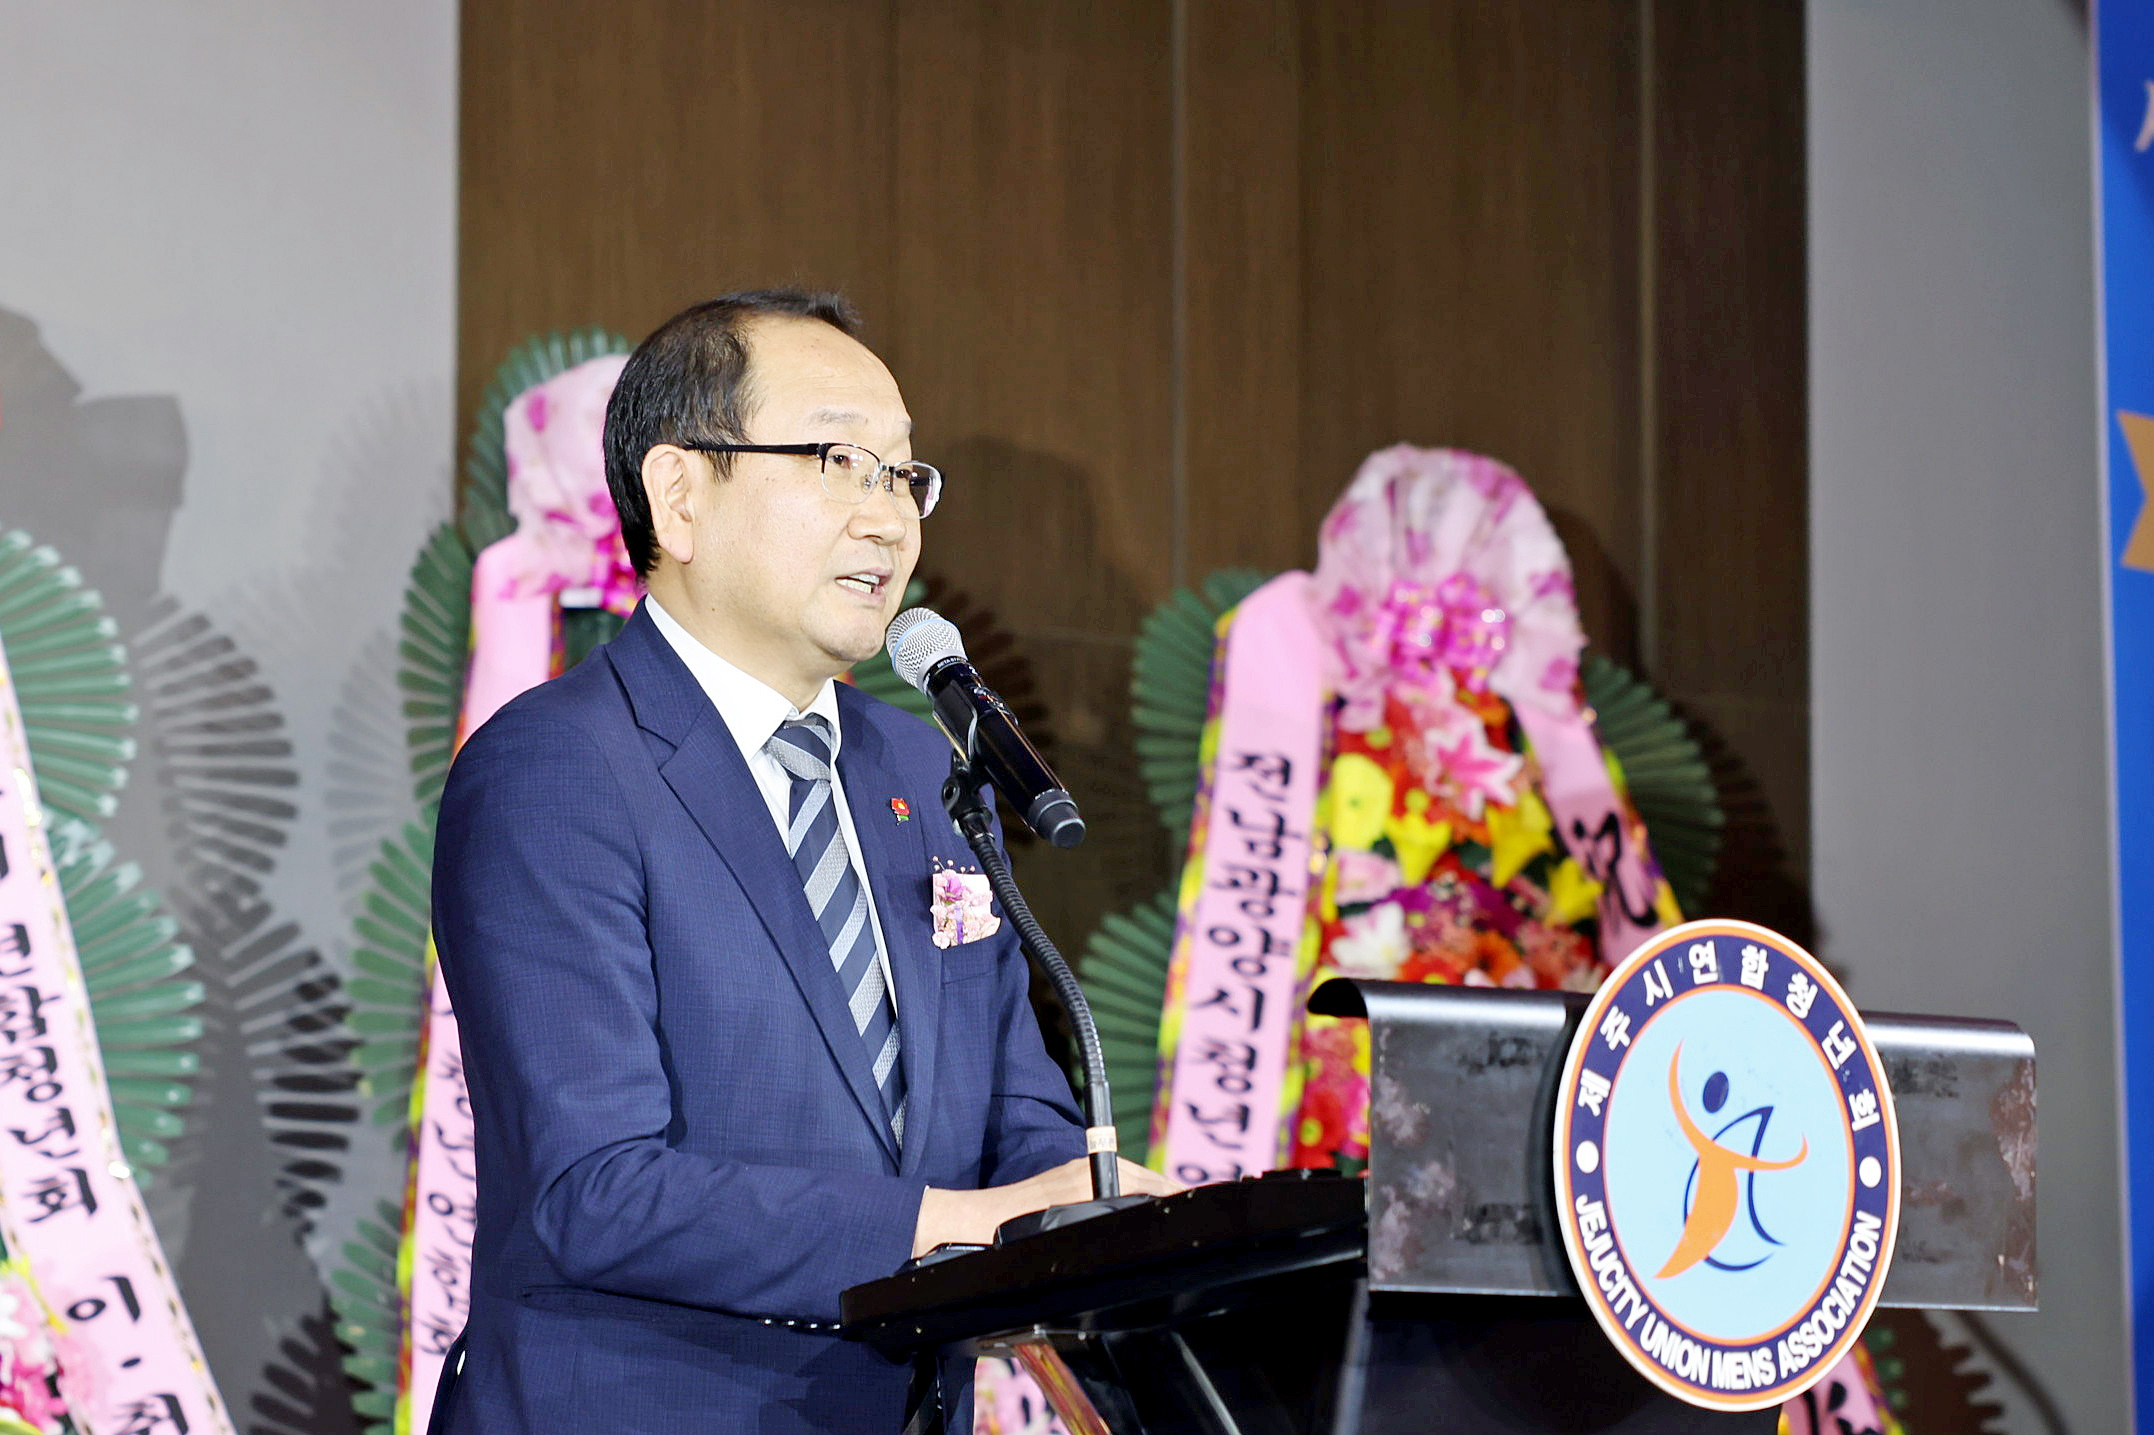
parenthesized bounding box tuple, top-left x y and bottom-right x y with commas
(831, 685, 941, 1174)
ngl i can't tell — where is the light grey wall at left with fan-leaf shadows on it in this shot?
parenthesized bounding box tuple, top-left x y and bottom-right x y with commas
(0, 0, 457, 1431)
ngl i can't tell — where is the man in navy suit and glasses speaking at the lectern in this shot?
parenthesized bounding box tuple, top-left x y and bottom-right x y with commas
(433, 291, 1172, 1435)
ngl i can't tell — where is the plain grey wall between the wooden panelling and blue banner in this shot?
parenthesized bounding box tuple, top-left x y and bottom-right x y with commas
(1807, 0, 2126, 1435)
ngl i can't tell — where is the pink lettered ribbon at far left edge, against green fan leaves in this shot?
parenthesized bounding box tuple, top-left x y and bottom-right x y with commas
(0, 637, 233, 1435)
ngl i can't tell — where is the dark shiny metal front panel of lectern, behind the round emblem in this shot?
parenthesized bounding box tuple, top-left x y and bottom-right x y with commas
(1310, 978, 2036, 1310)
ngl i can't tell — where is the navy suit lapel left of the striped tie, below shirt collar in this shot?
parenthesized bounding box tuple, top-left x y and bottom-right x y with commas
(605, 608, 911, 1157)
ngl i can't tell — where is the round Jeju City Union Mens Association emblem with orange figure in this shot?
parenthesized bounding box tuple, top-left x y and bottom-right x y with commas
(1555, 922, 1900, 1409)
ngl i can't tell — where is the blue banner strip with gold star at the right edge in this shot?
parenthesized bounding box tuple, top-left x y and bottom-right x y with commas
(2102, 0, 2154, 1435)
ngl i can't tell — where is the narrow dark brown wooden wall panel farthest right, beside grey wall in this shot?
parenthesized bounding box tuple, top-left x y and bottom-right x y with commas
(1650, 0, 1812, 939)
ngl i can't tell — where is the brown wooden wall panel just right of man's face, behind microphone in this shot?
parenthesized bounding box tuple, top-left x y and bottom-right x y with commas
(887, 0, 1174, 948)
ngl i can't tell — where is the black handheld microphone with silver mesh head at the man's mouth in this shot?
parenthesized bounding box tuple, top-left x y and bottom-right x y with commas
(887, 608, 1083, 847)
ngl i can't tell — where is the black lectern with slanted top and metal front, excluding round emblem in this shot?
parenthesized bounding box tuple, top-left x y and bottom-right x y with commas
(842, 978, 2036, 1435)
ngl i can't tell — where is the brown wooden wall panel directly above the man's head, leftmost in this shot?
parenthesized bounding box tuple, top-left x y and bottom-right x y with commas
(457, 0, 896, 433)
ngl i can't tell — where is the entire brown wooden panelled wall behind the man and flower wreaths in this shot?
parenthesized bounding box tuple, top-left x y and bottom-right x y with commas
(459, 0, 1807, 960)
